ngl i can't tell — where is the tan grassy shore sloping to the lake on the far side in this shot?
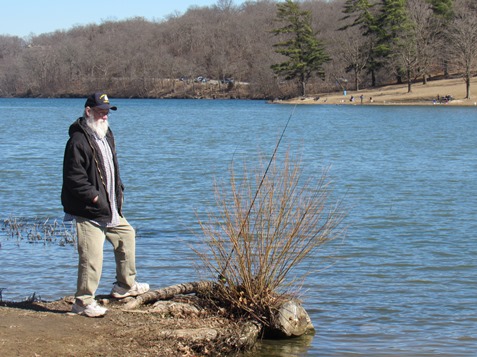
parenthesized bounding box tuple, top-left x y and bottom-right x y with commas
(274, 78, 477, 106)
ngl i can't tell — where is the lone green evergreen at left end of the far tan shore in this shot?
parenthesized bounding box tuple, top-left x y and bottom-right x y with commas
(271, 0, 330, 96)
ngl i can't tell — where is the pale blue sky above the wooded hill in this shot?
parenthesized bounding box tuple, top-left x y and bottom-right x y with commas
(0, 0, 244, 38)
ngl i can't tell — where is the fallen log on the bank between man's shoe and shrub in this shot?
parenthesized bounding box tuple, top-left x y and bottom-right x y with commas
(124, 281, 215, 310)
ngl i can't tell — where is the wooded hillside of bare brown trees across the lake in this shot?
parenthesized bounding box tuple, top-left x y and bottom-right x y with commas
(0, 0, 477, 98)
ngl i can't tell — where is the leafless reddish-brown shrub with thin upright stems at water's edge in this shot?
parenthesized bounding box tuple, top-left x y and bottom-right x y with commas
(196, 152, 344, 325)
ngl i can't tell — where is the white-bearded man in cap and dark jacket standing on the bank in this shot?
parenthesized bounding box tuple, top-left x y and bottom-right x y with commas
(61, 93, 149, 317)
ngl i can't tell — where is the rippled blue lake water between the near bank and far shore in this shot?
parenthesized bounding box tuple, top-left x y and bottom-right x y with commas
(0, 99, 477, 357)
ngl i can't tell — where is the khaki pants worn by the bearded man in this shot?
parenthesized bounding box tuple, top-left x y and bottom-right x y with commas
(75, 217, 136, 305)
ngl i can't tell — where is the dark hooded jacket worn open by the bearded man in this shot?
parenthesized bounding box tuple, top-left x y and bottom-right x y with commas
(61, 118, 124, 220)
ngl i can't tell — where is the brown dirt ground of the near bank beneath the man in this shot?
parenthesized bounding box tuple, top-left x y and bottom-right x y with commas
(0, 297, 249, 357)
